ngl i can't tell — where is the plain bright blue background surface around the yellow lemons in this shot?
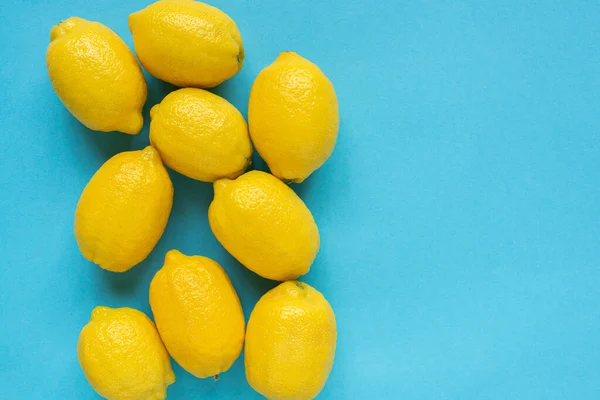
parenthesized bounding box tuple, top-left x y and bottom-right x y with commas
(0, 0, 600, 400)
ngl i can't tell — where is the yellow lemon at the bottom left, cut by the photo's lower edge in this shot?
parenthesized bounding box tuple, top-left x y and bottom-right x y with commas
(77, 307, 175, 400)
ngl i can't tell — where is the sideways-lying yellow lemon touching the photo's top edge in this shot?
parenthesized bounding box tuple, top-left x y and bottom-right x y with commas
(129, 0, 244, 87)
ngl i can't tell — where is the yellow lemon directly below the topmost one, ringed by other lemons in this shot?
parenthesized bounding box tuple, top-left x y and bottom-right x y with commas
(150, 88, 252, 182)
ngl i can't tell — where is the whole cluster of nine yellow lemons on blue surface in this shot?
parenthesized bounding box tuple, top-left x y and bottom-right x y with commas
(47, 0, 339, 400)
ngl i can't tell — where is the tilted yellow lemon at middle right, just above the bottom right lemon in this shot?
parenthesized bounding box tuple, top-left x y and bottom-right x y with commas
(208, 171, 320, 281)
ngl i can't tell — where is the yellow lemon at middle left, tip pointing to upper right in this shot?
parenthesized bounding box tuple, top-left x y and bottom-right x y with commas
(75, 146, 173, 272)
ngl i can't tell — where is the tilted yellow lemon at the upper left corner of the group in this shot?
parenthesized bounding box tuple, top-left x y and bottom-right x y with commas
(46, 17, 147, 135)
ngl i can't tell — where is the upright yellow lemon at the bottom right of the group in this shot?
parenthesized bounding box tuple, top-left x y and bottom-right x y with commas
(244, 281, 337, 400)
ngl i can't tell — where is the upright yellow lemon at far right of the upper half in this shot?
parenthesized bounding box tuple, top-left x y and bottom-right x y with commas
(248, 52, 339, 182)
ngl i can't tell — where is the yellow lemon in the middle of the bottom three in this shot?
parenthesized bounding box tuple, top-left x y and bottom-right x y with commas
(150, 250, 245, 378)
